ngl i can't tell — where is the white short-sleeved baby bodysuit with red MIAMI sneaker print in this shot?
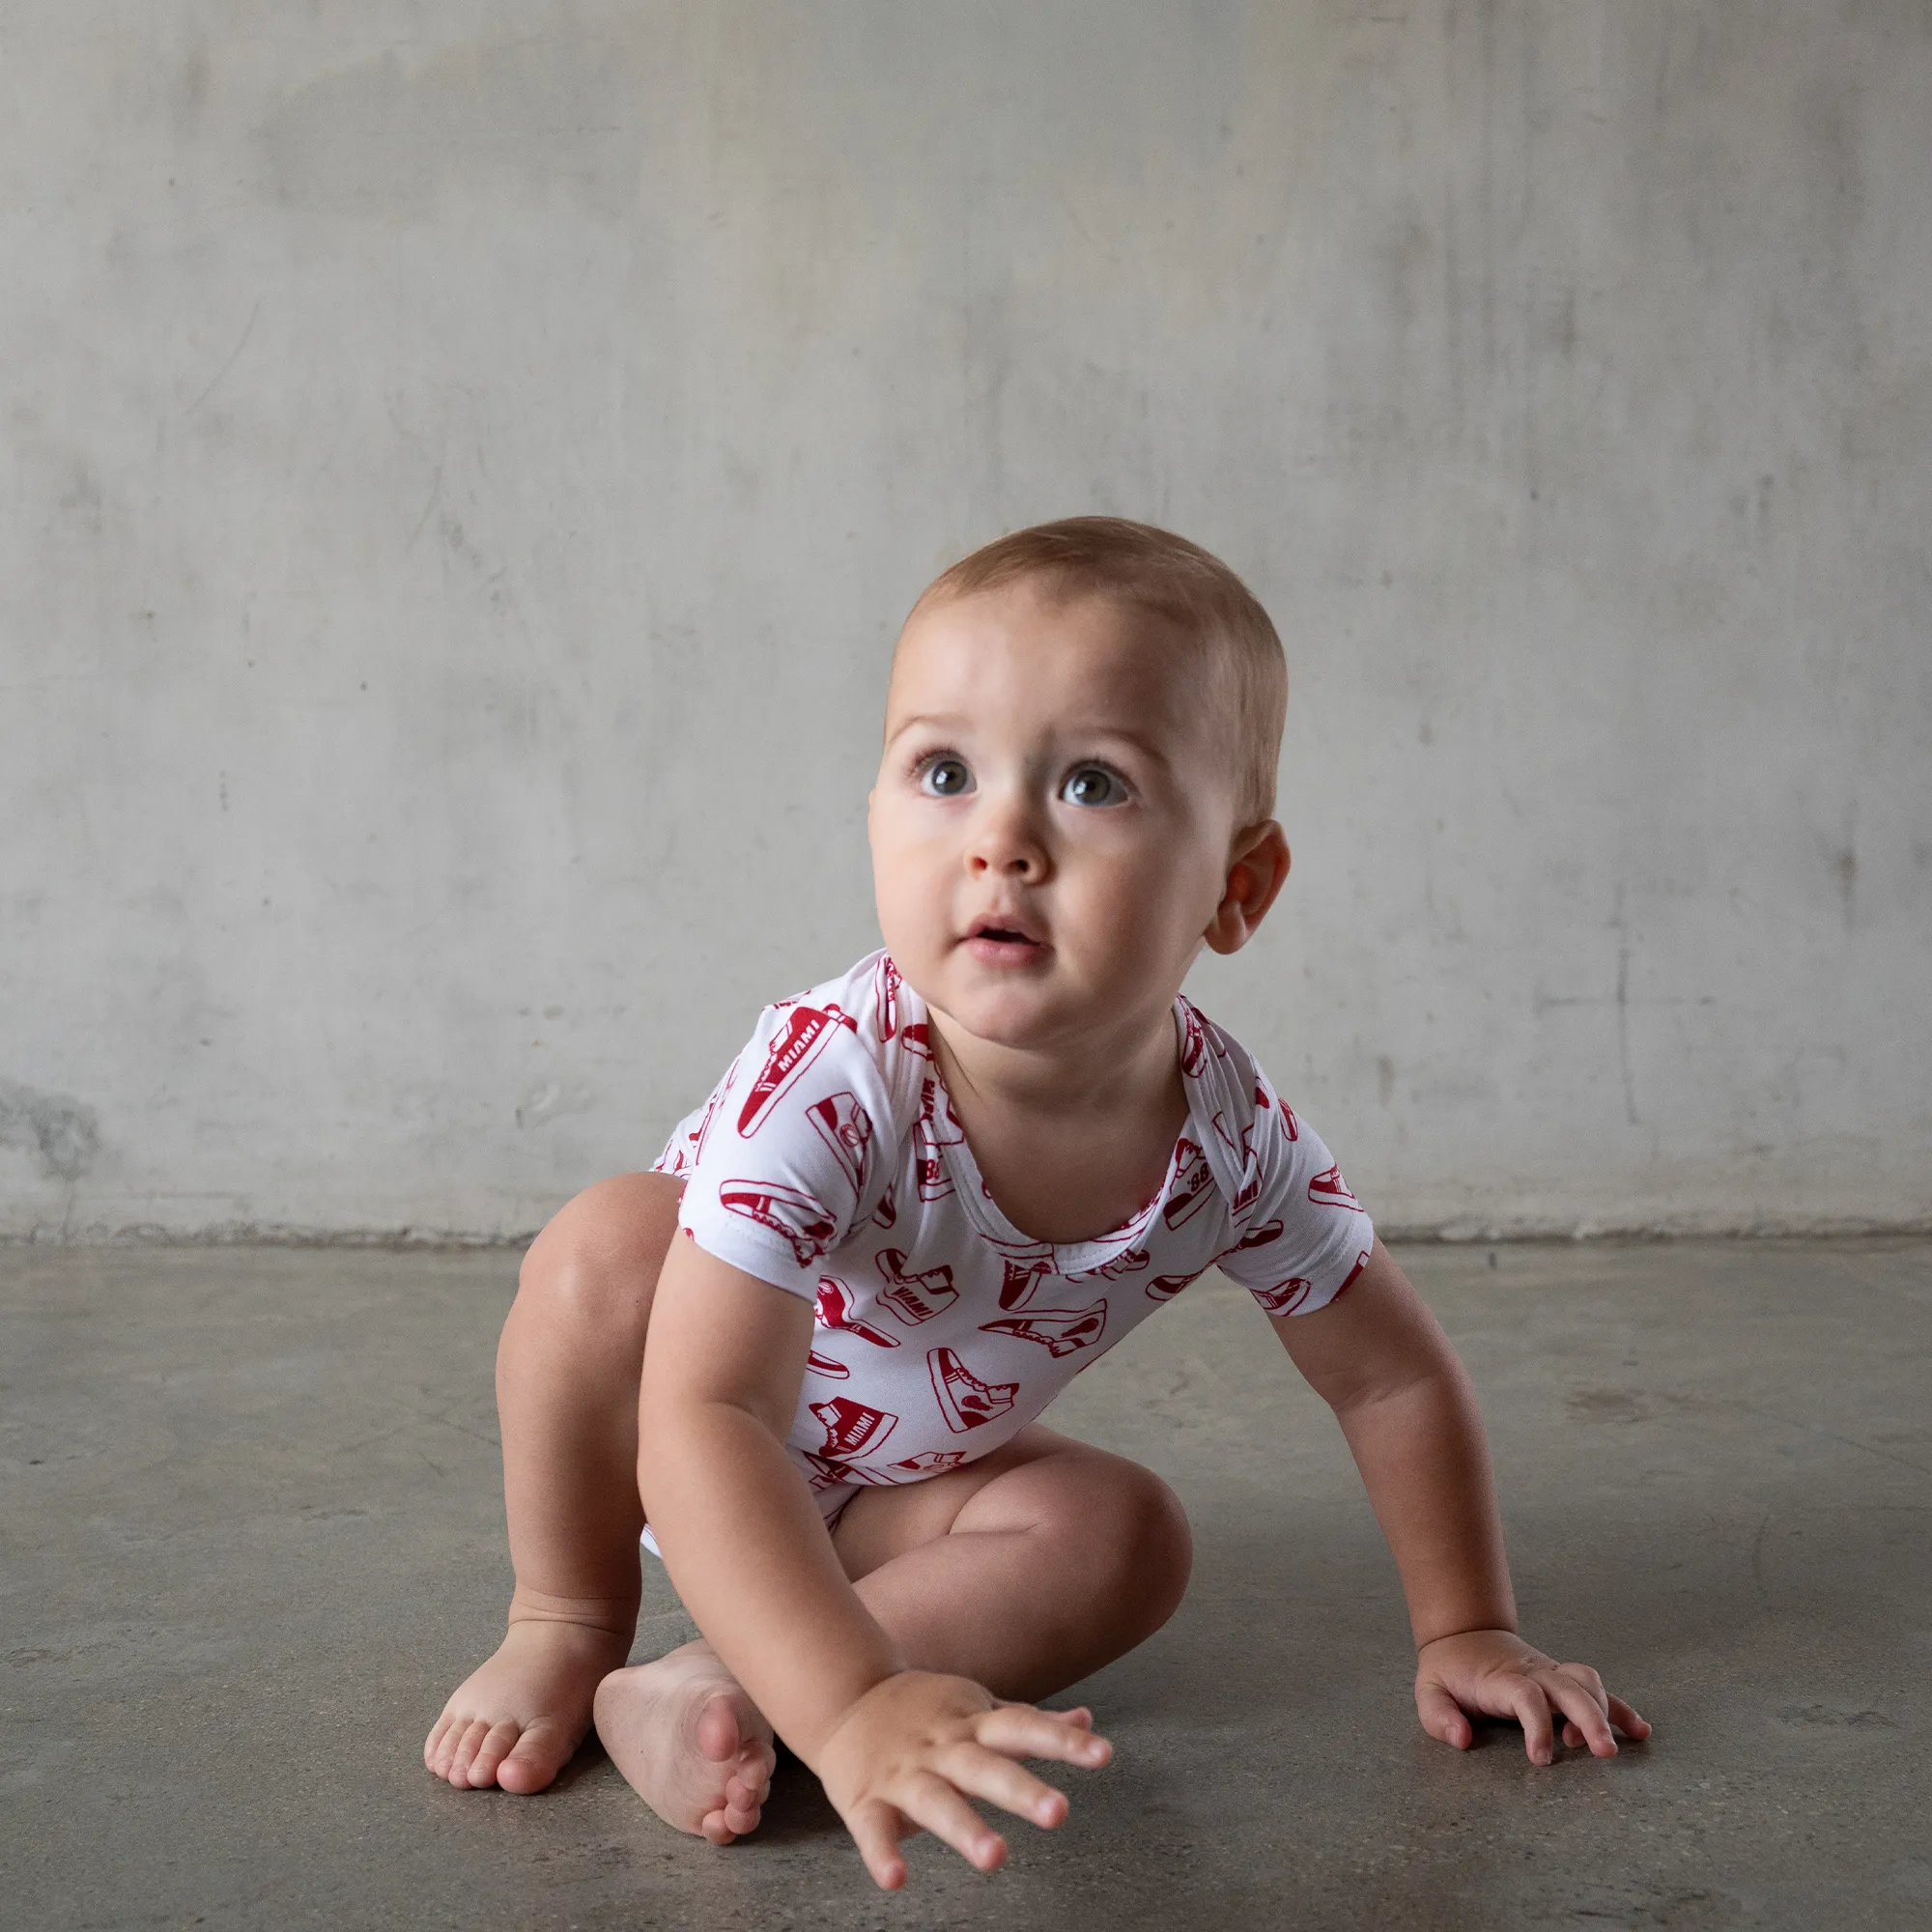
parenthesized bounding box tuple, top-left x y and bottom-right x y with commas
(645, 952, 1374, 1548)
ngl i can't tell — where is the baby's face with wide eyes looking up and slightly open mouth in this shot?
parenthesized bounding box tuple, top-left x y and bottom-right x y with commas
(871, 582, 1235, 1049)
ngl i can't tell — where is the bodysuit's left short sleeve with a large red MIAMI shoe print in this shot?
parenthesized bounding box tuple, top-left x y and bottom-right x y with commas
(659, 993, 891, 1298)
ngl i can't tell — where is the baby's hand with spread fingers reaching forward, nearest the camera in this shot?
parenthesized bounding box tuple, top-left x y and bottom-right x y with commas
(813, 1671, 1113, 1891)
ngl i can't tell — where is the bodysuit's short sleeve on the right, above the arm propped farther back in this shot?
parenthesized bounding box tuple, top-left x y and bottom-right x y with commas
(1217, 1072, 1376, 1316)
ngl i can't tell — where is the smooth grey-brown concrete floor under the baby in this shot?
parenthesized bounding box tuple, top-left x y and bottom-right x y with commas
(0, 1240, 1932, 1932)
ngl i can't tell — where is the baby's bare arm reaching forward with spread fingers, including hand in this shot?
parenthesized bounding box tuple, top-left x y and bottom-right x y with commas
(638, 1238, 1109, 1888)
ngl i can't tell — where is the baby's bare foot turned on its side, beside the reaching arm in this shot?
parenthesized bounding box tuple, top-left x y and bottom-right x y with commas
(597, 1640, 777, 1845)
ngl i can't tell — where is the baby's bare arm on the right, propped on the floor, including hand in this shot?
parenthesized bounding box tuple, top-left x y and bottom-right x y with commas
(1273, 1240, 1650, 1764)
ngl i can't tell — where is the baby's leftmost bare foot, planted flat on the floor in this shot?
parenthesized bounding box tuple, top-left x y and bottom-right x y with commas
(423, 1621, 630, 1793)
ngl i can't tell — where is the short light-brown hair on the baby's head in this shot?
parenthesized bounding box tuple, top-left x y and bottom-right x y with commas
(908, 516, 1289, 825)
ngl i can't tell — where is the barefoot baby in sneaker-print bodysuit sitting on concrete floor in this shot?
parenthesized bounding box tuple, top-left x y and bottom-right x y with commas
(423, 518, 1650, 1888)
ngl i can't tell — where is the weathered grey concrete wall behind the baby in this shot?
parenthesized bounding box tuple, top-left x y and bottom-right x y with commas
(0, 0, 1932, 1238)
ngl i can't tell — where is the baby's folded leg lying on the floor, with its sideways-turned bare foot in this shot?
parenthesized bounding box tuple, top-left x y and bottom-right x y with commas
(597, 1424, 1190, 1843)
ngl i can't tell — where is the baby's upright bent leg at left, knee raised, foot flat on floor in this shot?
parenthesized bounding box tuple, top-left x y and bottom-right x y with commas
(423, 1175, 757, 1791)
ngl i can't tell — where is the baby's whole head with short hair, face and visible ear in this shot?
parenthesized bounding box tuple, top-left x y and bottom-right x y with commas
(871, 516, 1289, 1047)
